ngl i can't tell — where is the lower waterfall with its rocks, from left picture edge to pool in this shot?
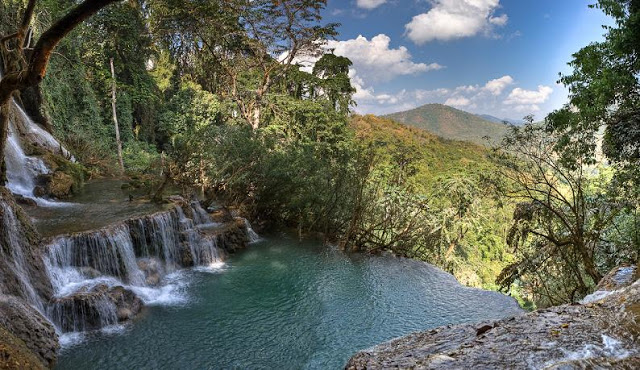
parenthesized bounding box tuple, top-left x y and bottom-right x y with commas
(0, 189, 257, 342)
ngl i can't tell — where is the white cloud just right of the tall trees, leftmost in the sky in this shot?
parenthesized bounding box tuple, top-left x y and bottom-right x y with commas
(327, 34, 444, 83)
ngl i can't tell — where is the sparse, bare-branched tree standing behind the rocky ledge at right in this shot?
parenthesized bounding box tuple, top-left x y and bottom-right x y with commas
(495, 120, 623, 304)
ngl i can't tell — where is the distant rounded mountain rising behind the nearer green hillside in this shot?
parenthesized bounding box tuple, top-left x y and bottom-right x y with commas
(384, 104, 508, 145)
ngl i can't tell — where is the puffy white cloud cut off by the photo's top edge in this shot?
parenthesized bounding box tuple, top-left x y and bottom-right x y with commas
(405, 0, 509, 45)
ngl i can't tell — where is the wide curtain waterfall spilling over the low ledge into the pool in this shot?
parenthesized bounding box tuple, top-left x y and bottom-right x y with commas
(44, 203, 238, 332)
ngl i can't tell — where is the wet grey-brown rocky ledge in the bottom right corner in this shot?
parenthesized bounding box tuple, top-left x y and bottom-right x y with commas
(346, 266, 640, 370)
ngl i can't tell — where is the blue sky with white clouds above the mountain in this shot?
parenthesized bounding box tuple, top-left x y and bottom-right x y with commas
(324, 0, 610, 118)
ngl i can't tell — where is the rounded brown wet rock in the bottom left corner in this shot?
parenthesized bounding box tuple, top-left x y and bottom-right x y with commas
(0, 295, 60, 368)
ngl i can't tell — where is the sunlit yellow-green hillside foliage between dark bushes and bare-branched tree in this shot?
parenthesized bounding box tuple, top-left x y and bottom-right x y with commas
(346, 116, 511, 288)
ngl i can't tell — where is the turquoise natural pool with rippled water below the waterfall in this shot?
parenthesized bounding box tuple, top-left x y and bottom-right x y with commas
(58, 235, 521, 369)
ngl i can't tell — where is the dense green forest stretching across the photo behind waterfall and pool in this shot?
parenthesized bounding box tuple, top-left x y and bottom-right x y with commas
(0, 0, 640, 307)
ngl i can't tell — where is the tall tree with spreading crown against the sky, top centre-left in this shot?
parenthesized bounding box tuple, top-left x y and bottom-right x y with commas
(151, 0, 337, 129)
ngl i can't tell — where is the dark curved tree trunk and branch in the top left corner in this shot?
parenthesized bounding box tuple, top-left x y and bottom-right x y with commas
(0, 0, 117, 185)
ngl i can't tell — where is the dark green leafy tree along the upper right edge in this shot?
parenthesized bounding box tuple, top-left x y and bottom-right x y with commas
(547, 0, 640, 185)
